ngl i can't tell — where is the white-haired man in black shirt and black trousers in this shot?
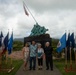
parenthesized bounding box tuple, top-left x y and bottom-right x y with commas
(44, 42, 53, 70)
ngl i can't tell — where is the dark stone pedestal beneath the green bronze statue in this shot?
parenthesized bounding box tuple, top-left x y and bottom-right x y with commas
(24, 34, 52, 48)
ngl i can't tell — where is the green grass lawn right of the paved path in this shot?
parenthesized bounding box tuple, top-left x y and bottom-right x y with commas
(54, 60, 76, 75)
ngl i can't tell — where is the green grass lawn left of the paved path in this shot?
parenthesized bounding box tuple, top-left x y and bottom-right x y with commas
(0, 59, 23, 75)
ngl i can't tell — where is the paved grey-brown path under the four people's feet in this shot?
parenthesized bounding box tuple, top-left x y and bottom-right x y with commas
(16, 61, 62, 75)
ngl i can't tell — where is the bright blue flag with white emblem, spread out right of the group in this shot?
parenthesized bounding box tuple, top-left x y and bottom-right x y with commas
(57, 33, 66, 52)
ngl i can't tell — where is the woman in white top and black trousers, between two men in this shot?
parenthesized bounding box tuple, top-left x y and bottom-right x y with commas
(37, 43, 44, 70)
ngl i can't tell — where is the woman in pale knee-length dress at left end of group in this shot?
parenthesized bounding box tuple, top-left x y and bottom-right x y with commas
(22, 43, 29, 70)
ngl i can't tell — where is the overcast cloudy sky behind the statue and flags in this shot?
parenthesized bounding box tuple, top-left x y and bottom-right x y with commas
(0, 0, 76, 38)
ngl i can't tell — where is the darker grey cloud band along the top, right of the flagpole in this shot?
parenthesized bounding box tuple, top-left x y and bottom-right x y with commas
(24, 0, 76, 13)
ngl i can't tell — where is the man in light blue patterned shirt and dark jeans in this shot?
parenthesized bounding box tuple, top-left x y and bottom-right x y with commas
(29, 41, 37, 70)
